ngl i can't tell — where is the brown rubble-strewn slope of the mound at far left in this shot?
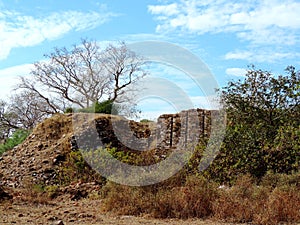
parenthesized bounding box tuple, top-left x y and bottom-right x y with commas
(0, 114, 73, 187)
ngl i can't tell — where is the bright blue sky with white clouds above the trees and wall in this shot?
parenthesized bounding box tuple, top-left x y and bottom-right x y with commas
(0, 0, 300, 119)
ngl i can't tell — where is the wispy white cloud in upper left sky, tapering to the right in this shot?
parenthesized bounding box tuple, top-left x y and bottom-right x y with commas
(0, 8, 114, 60)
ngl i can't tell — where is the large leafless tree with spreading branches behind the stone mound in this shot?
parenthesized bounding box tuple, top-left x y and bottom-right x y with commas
(18, 40, 146, 113)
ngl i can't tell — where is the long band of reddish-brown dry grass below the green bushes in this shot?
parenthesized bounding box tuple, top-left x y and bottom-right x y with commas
(99, 172, 300, 225)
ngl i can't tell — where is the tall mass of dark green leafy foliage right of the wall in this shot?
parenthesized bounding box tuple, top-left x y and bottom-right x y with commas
(205, 67, 300, 182)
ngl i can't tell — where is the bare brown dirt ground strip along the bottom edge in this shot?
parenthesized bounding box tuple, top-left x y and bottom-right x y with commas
(0, 199, 246, 225)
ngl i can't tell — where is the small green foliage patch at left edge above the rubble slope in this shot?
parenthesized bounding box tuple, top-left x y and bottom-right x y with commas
(0, 130, 30, 155)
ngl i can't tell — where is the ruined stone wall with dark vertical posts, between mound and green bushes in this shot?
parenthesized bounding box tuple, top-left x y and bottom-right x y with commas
(72, 109, 212, 152)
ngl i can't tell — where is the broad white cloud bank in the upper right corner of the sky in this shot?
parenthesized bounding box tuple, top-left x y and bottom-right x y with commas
(148, 0, 300, 45)
